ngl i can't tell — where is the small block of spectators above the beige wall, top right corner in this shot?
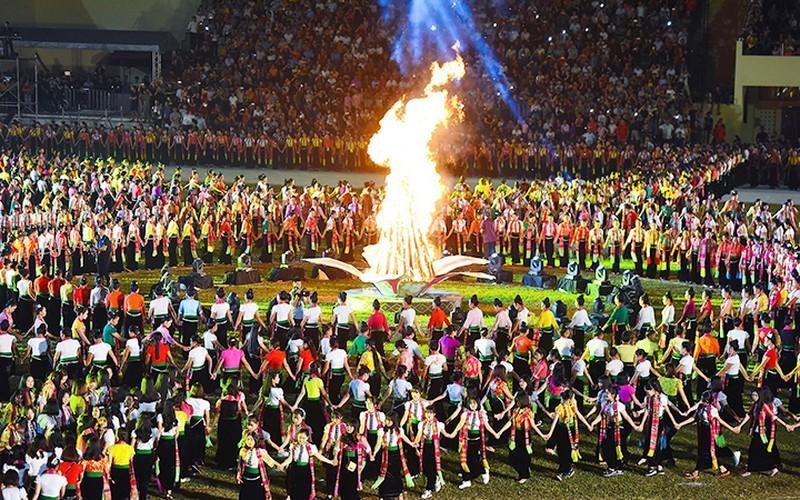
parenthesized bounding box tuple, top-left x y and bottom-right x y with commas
(742, 0, 800, 56)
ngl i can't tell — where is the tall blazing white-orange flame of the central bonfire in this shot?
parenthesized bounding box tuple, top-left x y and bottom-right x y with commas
(364, 55, 464, 281)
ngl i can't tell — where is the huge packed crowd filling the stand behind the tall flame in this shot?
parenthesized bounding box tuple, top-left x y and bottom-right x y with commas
(154, 0, 708, 174)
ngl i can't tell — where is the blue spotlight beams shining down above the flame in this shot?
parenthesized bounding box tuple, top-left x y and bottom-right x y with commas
(377, 0, 524, 123)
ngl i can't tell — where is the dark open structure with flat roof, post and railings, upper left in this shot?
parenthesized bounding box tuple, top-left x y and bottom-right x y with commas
(14, 27, 177, 119)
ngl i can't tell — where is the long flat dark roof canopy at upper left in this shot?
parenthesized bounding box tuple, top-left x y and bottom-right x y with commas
(14, 26, 178, 52)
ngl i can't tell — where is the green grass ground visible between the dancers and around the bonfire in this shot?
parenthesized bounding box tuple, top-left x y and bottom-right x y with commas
(115, 265, 800, 499)
